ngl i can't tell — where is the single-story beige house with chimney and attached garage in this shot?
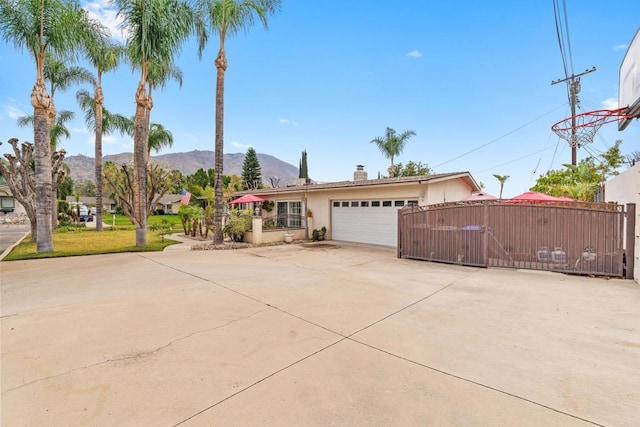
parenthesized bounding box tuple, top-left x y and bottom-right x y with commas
(240, 166, 480, 246)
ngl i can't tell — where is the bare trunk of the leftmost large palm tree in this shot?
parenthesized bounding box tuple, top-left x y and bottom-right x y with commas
(31, 79, 55, 253)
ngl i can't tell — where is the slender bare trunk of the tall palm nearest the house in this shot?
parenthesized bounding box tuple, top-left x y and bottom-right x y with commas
(213, 46, 227, 244)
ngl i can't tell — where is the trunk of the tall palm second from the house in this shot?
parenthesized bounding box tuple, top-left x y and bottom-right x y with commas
(133, 83, 150, 246)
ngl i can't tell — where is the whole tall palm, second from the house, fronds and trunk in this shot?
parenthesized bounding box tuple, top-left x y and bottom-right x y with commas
(116, 0, 193, 246)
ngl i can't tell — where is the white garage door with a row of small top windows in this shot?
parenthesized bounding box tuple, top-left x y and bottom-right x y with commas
(331, 199, 417, 246)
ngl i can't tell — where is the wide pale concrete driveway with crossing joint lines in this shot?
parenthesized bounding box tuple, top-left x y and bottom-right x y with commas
(0, 242, 640, 426)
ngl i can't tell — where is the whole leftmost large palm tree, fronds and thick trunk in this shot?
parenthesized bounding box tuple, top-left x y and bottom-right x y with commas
(0, 0, 105, 253)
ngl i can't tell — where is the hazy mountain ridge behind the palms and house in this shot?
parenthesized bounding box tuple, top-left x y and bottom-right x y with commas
(64, 150, 298, 187)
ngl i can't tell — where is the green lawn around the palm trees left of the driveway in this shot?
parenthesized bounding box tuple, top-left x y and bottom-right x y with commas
(3, 219, 182, 261)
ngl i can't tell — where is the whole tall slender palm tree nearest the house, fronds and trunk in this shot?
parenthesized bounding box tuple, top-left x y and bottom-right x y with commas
(196, 0, 280, 244)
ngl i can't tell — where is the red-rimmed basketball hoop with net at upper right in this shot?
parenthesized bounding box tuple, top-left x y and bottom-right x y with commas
(551, 107, 633, 148)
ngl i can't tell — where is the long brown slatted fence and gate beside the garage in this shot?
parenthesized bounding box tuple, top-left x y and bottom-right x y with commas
(398, 201, 635, 278)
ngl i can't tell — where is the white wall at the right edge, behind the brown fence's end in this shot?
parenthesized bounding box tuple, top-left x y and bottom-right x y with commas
(604, 163, 640, 283)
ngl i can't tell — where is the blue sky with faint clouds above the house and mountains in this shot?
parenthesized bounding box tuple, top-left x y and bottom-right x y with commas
(0, 0, 640, 197)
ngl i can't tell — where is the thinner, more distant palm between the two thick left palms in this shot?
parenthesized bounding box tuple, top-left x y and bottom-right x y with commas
(76, 40, 124, 231)
